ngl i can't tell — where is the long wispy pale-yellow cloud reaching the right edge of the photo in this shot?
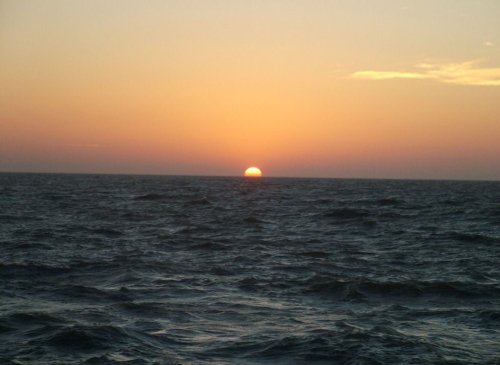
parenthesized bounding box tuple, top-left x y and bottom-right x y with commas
(350, 61, 500, 86)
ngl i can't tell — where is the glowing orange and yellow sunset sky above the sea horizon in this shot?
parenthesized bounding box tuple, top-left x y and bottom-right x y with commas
(0, 0, 500, 180)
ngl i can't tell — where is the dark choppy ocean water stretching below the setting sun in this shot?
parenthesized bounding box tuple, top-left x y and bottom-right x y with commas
(0, 174, 500, 365)
